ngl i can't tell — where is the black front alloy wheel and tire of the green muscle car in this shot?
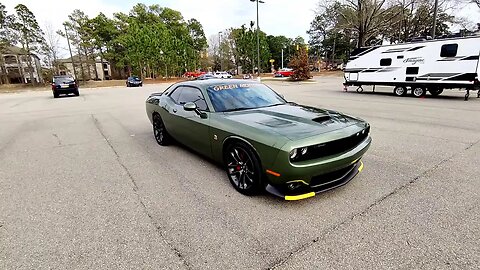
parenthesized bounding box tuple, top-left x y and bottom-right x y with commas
(224, 142, 262, 196)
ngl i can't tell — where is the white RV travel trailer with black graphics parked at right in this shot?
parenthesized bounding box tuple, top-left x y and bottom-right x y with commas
(344, 36, 480, 100)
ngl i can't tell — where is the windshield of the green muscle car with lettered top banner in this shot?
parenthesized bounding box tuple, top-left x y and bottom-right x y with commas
(207, 83, 285, 112)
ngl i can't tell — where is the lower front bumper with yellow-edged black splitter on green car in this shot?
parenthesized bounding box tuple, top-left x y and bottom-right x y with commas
(266, 160, 363, 201)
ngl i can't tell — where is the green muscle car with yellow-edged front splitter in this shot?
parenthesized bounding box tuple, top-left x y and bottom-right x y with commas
(146, 79, 371, 200)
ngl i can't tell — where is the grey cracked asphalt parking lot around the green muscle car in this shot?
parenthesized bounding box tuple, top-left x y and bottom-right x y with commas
(0, 77, 480, 269)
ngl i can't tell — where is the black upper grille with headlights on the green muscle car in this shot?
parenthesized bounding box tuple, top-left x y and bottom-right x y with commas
(293, 126, 370, 162)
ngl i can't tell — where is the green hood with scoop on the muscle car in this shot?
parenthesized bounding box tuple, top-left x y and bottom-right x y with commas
(224, 103, 363, 140)
